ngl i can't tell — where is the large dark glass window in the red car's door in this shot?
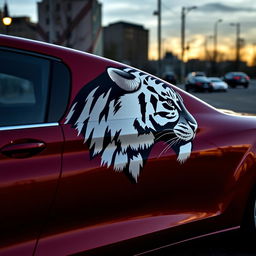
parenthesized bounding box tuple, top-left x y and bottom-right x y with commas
(0, 50, 50, 126)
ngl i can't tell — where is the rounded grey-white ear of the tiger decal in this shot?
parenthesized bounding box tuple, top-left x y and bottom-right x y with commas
(107, 68, 140, 92)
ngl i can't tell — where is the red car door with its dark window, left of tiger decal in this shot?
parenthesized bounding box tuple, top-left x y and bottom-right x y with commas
(0, 47, 65, 255)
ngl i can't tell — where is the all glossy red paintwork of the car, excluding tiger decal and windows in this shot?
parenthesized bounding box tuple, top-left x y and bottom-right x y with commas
(0, 36, 256, 255)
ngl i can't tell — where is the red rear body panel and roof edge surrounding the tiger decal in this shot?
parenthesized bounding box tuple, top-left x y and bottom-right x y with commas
(0, 36, 256, 255)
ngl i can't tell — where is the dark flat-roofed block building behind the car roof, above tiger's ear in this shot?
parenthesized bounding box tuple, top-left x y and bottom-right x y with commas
(104, 22, 149, 68)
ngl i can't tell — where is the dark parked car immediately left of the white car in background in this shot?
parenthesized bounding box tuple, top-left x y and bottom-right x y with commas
(185, 75, 213, 92)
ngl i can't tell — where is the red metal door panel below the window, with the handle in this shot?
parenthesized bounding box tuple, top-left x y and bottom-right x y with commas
(0, 124, 63, 255)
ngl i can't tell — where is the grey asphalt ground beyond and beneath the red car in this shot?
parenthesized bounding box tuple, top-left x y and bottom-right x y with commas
(155, 80, 256, 256)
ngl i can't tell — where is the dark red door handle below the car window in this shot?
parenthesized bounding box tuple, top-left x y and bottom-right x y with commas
(1, 141, 46, 158)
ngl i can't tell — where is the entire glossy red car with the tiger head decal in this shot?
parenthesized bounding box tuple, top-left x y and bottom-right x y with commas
(0, 35, 256, 256)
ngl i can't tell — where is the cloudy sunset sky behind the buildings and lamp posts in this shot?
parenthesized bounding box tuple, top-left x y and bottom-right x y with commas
(0, 0, 256, 63)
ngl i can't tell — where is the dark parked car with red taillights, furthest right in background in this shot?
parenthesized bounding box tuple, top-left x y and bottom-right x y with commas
(223, 72, 250, 88)
